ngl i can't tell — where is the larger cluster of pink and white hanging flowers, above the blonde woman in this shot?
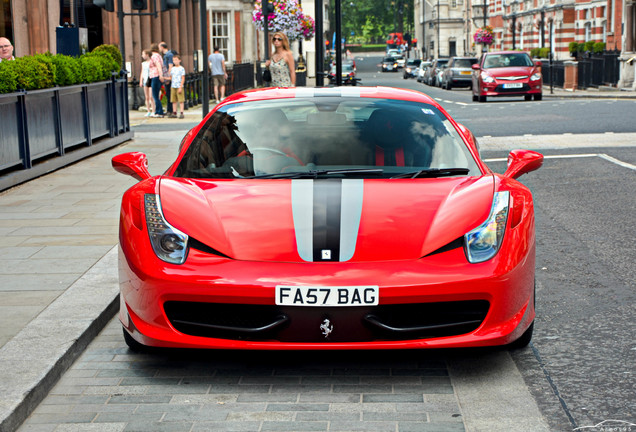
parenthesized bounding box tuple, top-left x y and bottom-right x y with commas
(252, 0, 315, 40)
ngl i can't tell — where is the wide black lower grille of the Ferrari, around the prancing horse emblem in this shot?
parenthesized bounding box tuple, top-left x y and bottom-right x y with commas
(164, 300, 489, 342)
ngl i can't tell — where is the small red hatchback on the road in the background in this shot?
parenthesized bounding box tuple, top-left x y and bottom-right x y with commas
(472, 51, 543, 102)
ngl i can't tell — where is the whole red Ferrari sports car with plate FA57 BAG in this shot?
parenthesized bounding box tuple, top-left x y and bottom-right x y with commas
(113, 87, 543, 350)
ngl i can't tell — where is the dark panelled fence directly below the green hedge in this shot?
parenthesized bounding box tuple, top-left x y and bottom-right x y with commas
(0, 75, 130, 176)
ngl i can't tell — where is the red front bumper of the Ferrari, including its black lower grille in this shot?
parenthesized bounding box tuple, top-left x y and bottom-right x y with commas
(119, 238, 535, 349)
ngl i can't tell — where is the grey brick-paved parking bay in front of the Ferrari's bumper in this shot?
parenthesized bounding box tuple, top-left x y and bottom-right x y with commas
(19, 319, 465, 432)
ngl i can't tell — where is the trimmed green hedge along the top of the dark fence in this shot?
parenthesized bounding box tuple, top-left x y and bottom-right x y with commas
(0, 45, 121, 93)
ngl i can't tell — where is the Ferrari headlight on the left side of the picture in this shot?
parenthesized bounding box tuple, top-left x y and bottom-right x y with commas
(144, 194, 188, 264)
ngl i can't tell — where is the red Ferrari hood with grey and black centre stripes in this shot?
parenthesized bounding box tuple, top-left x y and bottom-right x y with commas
(159, 175, 494, 262)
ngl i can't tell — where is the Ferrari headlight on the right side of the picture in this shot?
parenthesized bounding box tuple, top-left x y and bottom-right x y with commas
(464, 192, 510, 263)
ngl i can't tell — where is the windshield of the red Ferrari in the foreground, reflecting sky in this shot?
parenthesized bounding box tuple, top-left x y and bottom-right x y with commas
(175, 97, 481, 178)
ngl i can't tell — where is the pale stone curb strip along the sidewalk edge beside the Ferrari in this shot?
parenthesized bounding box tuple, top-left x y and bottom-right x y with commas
(0, 246, 119, 432)
